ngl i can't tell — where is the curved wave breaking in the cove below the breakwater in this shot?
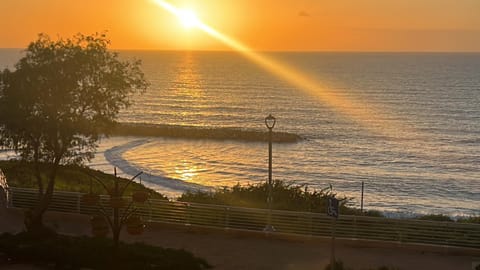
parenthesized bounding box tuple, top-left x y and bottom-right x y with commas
(104, 139, 211, 192)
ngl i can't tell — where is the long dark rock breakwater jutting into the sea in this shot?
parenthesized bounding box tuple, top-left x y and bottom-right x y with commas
(111, 123, 303, 143)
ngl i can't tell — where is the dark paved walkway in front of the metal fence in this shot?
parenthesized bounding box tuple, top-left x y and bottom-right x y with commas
(0, 209, 480, 270)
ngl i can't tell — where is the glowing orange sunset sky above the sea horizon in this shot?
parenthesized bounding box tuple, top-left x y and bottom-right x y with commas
(0, 0, 480, 51)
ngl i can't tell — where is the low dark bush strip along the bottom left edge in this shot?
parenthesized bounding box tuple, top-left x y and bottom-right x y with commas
(0, 233, 211, 270)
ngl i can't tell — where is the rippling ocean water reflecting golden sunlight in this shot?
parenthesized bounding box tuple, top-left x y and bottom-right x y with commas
(0, 49, 480, 216)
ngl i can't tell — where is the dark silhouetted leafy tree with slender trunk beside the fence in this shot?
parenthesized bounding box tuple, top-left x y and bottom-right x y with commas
(0, 34, 148, 230)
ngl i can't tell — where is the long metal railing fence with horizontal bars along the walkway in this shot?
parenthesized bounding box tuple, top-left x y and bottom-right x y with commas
(9, 187, 480, 249)
